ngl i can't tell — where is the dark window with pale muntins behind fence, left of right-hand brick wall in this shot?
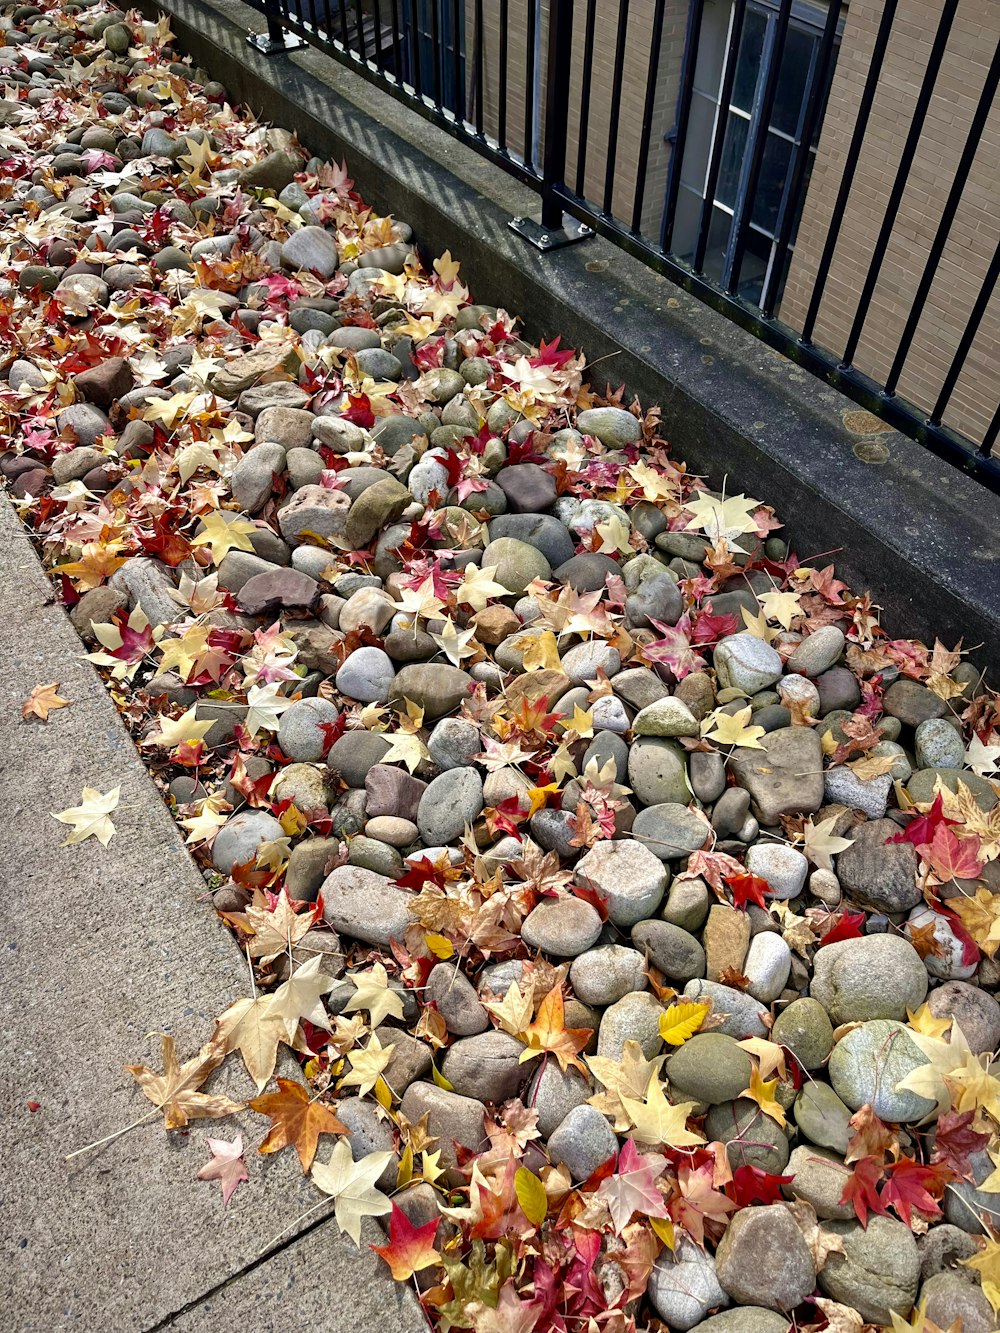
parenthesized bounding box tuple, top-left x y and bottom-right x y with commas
(673, 0, 839, 303)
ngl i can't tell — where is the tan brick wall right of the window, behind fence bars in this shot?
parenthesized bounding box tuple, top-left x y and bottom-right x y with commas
(780, 0, 1000, 441)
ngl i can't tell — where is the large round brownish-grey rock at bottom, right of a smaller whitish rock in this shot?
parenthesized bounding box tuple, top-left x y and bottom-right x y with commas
(716, 1204, 816, 1312)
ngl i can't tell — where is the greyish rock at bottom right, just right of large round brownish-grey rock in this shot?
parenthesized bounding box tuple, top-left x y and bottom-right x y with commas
(819, 1216, 920, 1324)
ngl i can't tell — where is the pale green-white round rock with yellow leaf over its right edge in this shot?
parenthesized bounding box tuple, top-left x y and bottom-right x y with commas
(828, 1018, 935, 1124)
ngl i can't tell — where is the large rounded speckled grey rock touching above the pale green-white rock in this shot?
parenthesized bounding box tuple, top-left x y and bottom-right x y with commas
(809, 934, 927, 1026)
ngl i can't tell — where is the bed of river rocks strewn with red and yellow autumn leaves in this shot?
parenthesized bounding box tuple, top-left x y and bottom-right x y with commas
(0, 0, 1000, 1333)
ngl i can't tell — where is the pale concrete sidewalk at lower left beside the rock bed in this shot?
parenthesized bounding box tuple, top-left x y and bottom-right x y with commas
(0, 497, 425, 1333)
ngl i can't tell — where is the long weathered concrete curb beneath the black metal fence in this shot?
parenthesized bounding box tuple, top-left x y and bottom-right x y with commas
(141, 0, 1000, 667)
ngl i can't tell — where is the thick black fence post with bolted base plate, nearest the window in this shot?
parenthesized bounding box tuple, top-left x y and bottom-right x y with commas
(511, 0, 593, 251)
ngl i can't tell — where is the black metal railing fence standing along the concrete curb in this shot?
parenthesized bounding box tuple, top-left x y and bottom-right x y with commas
(252, 0, 1000, 491)
